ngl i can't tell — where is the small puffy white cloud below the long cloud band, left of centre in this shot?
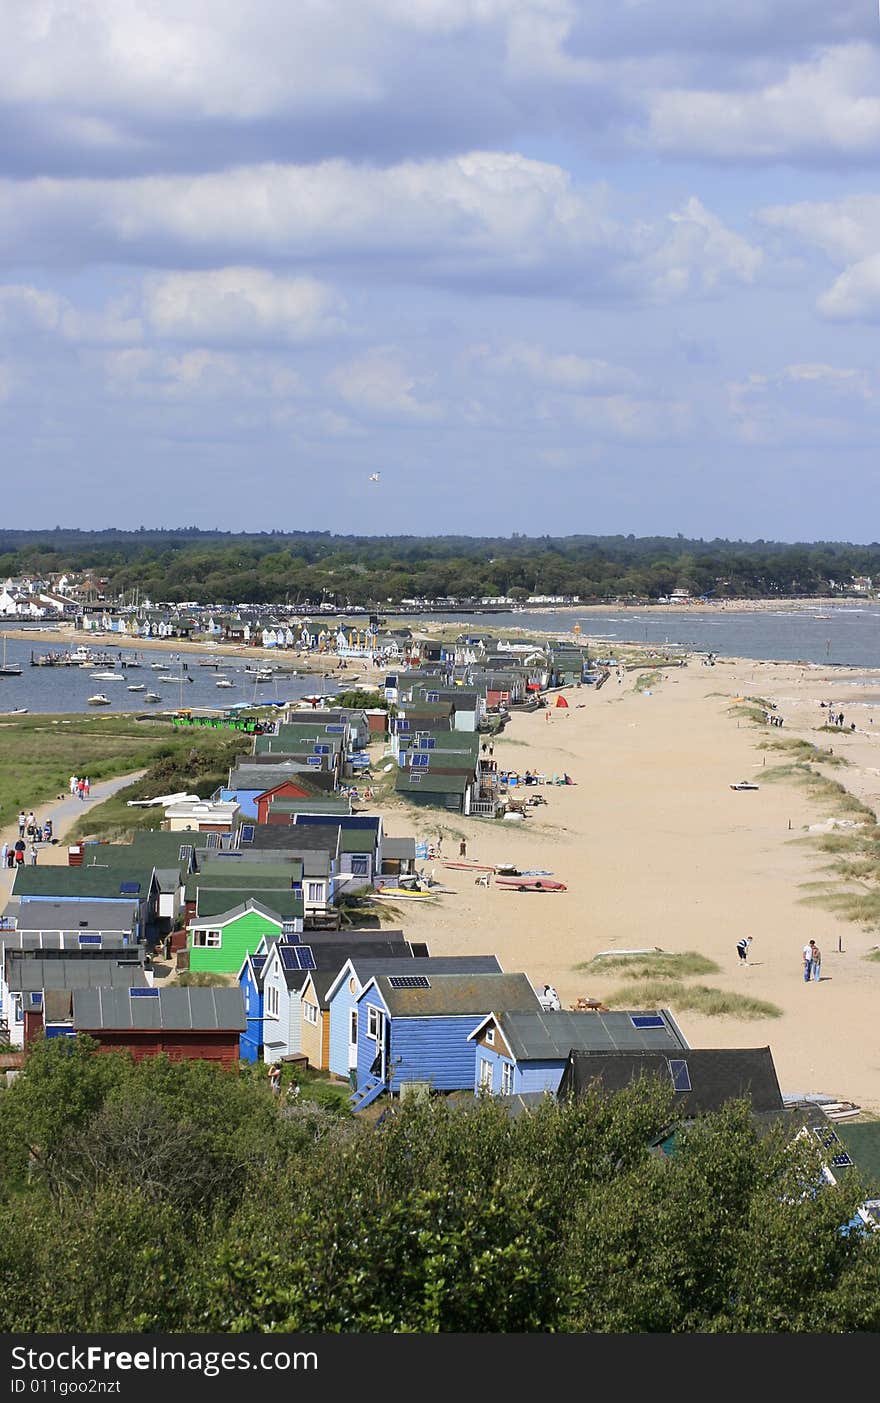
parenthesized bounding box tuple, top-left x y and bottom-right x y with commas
(145, 268, 344, 345)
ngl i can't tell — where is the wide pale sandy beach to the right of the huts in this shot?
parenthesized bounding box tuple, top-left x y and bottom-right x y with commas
(359, 659, 880, 1114)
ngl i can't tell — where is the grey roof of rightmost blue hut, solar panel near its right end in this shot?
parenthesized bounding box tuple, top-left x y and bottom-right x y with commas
(477, 1009, 688, 1062)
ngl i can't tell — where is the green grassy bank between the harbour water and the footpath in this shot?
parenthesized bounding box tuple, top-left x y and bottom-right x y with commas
(0, 716, 248, 832)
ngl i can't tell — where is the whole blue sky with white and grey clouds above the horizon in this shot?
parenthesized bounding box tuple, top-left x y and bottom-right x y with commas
(0, 0, 880, 542)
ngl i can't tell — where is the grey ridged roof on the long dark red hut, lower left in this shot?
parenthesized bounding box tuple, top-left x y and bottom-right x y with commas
(73, 985, 247, 1033)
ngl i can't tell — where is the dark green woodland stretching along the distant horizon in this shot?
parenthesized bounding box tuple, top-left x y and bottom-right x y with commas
(0, 528, 880, 607)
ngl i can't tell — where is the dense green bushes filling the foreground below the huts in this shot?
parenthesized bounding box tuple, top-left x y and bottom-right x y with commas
(0, 1037, 880, 1333)
